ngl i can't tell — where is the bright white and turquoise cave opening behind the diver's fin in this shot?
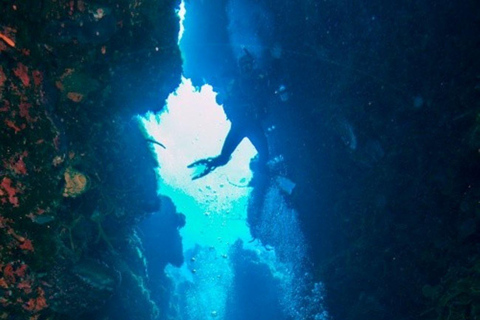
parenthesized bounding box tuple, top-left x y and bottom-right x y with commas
(144, 78, 262, 318)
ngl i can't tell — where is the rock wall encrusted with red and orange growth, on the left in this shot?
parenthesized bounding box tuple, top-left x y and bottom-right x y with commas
(0, 0, 181, 320)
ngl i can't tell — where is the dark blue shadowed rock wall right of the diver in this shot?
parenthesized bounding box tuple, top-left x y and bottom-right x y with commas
(265, 1, 480, 320)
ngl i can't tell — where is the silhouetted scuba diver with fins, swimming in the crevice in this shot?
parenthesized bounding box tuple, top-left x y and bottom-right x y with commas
(188, 48, 270, 180)
